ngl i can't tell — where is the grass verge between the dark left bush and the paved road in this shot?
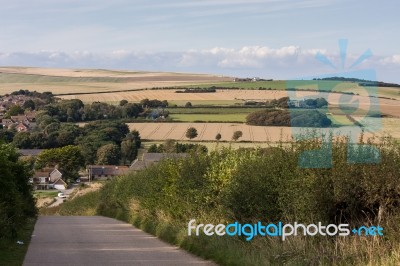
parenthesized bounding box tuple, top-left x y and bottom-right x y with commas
(0, 219, 36, 266)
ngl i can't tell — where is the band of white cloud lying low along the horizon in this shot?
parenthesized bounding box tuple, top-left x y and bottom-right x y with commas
(0, 46, 400, 82)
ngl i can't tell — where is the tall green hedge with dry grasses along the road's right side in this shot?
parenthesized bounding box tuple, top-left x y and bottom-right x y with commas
(60, 138, 400, 265)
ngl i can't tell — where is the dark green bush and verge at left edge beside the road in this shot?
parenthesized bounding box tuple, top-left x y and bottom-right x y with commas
(0, 142, 37, 265)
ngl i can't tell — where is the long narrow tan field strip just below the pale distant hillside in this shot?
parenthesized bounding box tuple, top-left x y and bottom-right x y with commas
(62, 90, 400, 117)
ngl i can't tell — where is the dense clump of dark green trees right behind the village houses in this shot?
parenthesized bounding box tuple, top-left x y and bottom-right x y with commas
(12, 121, 141, 172)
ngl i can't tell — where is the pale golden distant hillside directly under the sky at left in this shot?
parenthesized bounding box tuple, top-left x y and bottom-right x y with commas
(0, 67, 233, 95)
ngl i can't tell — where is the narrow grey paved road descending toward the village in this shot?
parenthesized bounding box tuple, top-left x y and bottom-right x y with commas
(24, 216, 214, 266)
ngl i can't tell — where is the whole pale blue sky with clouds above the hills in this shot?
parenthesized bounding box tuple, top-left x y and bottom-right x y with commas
(0, 0, 400, 83)
